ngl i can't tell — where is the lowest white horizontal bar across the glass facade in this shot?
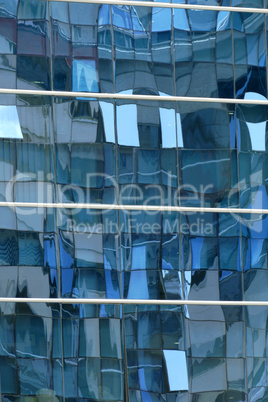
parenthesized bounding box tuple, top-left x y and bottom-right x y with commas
(0, 297, 268, 307)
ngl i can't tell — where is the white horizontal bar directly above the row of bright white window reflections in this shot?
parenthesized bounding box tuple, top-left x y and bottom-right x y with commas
(0, 88, 268, 105)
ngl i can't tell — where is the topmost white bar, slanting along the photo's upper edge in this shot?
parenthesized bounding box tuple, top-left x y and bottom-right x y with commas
(45, 0, 268, 14)
